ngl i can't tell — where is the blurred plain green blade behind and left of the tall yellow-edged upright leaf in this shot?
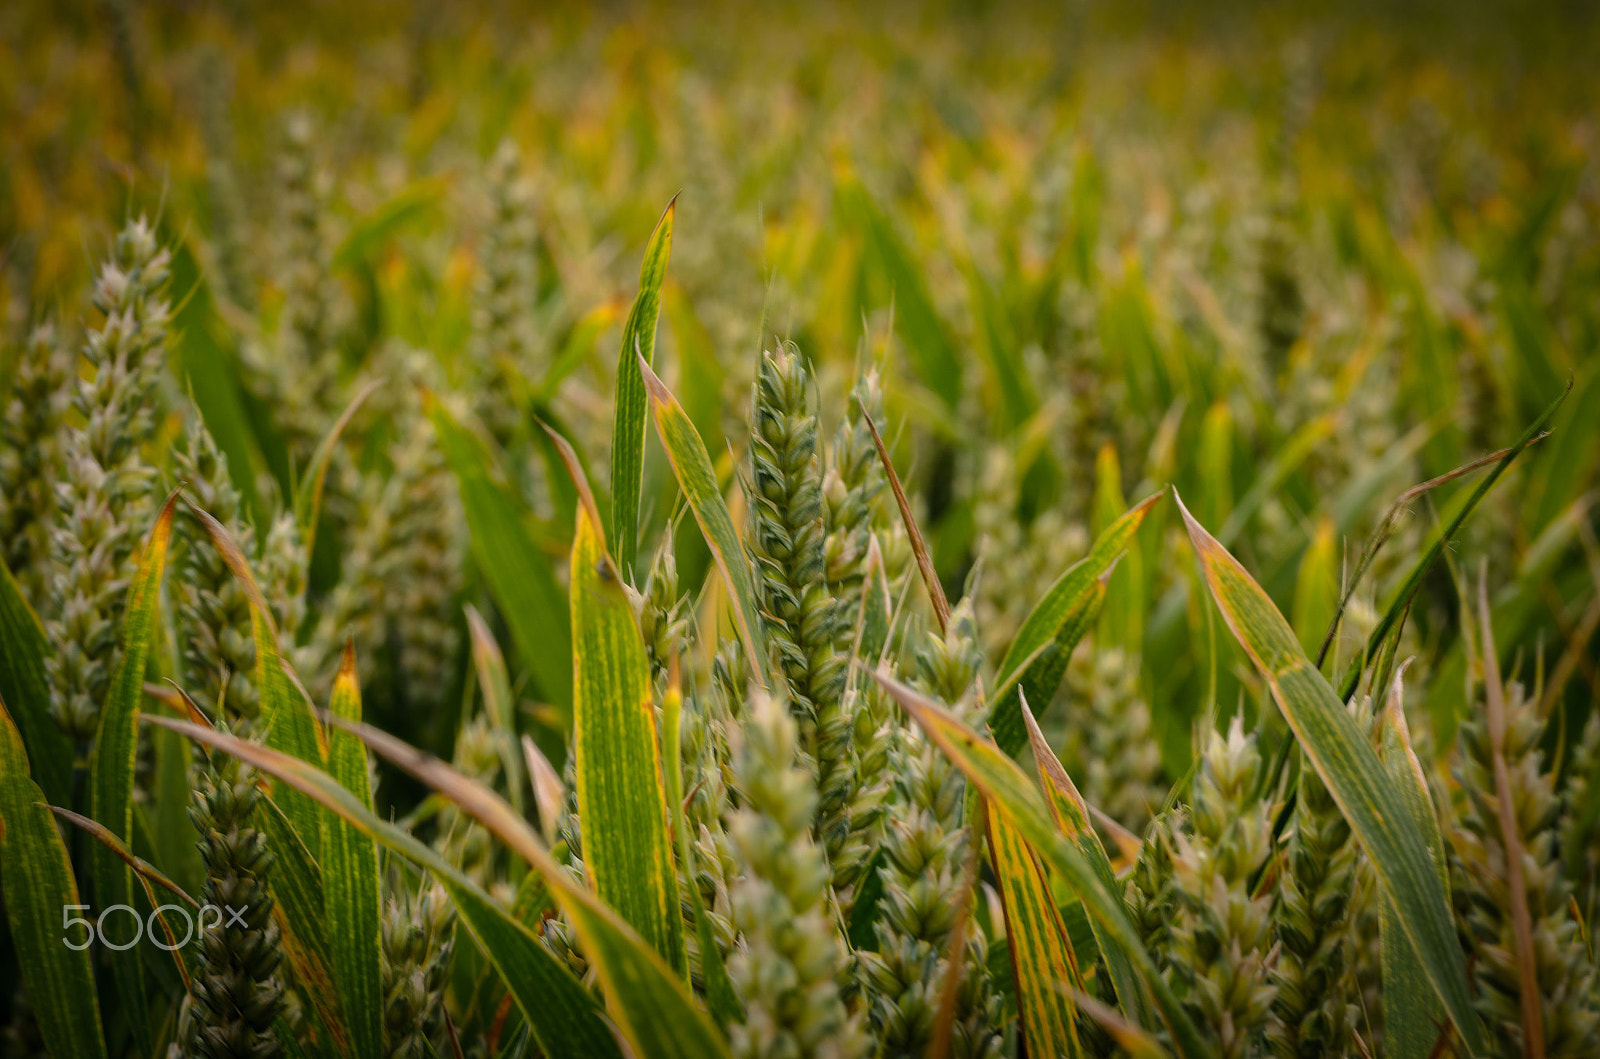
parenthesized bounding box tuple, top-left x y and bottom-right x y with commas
(429, 400, 573, 713)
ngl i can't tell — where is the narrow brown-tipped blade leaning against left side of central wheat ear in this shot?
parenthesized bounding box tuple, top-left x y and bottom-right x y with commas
(638, 362, 771, 685)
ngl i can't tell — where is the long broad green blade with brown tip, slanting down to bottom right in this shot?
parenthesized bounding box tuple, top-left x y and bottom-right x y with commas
(1178, 501, 1486, 1054)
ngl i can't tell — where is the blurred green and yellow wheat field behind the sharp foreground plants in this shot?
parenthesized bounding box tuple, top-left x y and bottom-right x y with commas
(0, 0, 1600, 789)
